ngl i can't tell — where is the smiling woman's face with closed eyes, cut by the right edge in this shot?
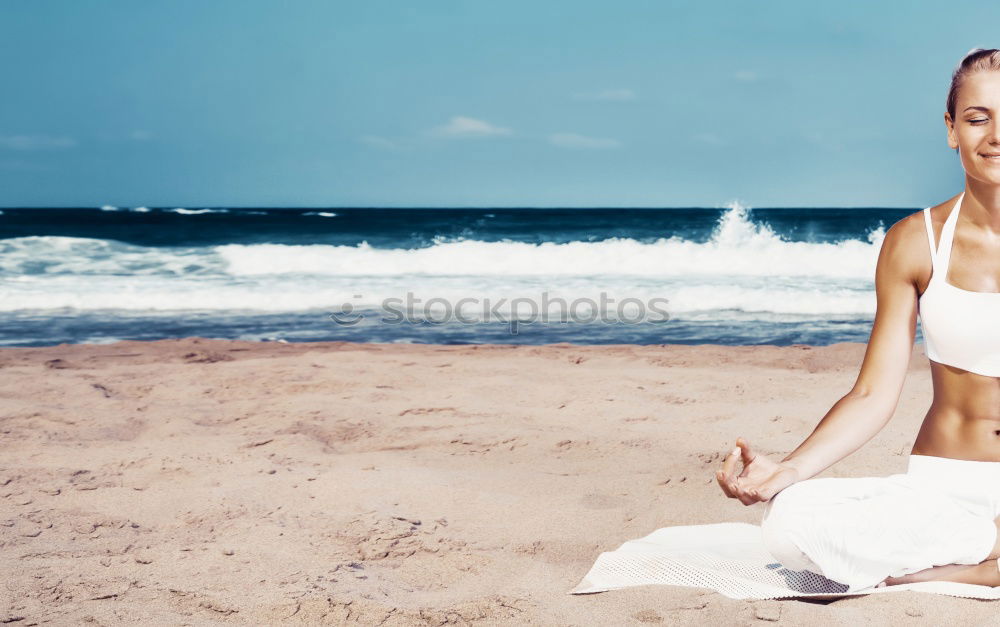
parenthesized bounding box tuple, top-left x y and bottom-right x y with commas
(944, 71, 1000, 185)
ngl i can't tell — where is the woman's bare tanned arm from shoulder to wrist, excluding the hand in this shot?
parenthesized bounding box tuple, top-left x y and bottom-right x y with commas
(782, 214, 930, 480)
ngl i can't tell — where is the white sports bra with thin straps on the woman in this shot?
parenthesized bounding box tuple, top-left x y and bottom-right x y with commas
(918, 192, 1000, 377)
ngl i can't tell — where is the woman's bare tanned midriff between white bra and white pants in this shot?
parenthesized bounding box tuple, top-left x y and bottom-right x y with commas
(911, 362, 1000, 462)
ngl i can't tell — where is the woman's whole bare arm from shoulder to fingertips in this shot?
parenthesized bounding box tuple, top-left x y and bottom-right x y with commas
(716, 213, 930, 505)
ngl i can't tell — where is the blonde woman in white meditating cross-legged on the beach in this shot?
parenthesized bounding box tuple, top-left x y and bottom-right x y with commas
(716, 48, 1000, 591)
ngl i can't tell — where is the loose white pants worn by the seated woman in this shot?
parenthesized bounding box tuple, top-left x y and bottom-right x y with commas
(761, 455, 1000, 592)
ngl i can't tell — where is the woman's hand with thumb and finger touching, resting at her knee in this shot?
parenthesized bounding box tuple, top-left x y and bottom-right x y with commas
(715, 438, 799, 505)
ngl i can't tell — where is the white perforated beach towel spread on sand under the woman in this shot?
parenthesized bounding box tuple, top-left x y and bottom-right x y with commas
(569, 523, 1000, 599)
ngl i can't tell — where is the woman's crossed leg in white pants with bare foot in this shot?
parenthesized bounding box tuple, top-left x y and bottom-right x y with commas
(761, 475, 1000, 590)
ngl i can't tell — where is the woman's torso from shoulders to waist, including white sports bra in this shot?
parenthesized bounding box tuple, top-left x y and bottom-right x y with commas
(912, 194, 1000, 461)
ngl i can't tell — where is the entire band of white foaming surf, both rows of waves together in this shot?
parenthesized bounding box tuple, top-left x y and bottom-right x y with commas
(0, 208, 885, 320)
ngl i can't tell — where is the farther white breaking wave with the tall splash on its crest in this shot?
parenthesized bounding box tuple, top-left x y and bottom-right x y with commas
(215, 209, 885, 279)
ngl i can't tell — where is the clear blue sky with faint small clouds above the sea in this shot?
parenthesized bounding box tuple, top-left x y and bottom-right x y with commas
(0, 0, 1000, 208)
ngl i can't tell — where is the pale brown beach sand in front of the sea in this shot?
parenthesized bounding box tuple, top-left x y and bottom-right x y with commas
(0, 338, 988, 626)
